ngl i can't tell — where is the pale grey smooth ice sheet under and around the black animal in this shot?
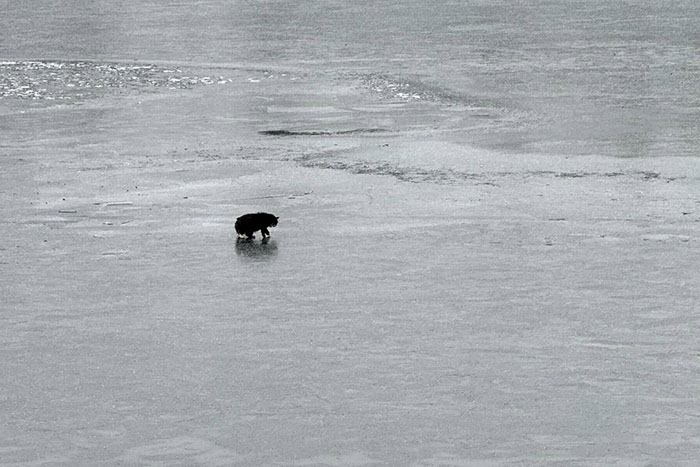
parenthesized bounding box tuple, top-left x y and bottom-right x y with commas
(0, 72, 700, 466)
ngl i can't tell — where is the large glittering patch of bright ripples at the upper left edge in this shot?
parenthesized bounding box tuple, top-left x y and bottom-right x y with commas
(0, 60, 231, 101)
